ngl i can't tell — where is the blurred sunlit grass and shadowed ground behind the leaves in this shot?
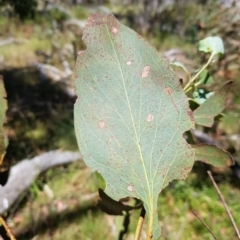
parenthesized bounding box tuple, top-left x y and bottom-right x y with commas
(0, 0, 240, 240)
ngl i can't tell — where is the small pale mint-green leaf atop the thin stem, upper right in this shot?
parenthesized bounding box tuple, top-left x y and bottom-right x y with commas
(198, 37, 224, 55)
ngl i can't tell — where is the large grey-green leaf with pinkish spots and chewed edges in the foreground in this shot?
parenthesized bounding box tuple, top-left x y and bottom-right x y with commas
(74, 15, 195, 240)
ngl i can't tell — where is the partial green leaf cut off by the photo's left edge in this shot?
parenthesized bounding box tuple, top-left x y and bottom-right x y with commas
(0, 75, 8, 164)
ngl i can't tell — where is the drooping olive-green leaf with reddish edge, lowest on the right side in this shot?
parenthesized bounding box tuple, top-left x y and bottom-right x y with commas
(191, 144, 234, 167)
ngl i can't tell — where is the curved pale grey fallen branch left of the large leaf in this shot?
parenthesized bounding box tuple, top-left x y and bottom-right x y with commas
(0, 150, 82, 214)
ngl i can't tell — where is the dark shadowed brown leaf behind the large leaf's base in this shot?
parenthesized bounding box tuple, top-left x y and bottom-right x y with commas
(98, 189, 142, 216)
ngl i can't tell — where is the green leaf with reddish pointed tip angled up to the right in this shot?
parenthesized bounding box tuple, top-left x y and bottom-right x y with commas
(193, 81, 232, 127)
